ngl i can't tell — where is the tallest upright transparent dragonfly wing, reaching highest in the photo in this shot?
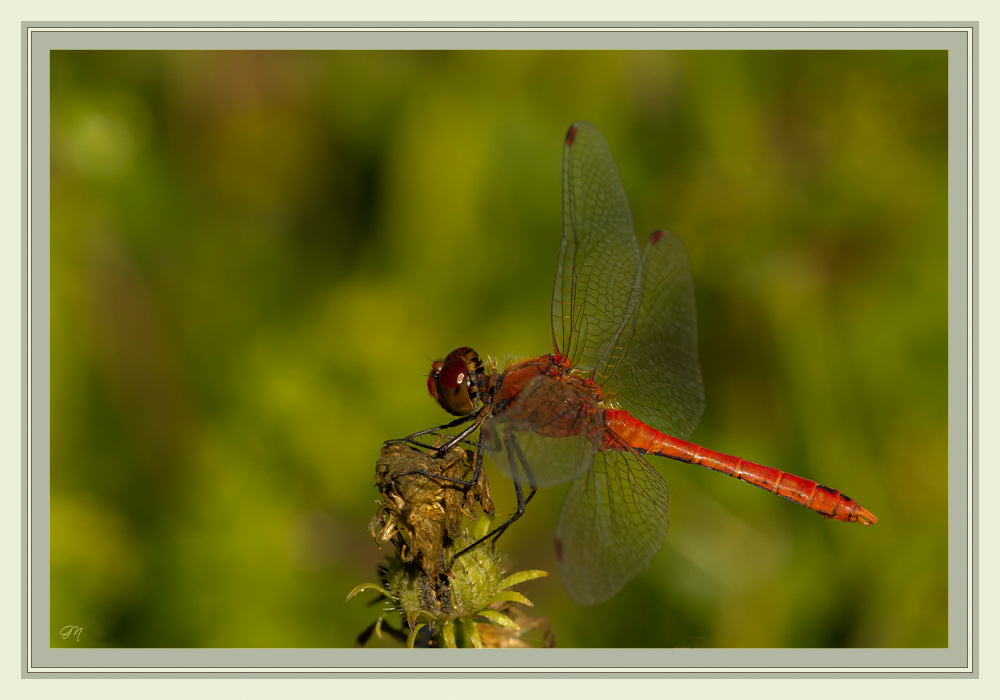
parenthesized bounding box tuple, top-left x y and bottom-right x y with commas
(552, 122, 639, 379)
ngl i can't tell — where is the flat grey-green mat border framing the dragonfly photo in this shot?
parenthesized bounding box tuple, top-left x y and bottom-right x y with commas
(22, 22, 978, 678)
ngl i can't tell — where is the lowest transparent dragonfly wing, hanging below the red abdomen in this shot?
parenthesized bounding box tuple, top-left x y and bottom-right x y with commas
(556, 438, 667, 605)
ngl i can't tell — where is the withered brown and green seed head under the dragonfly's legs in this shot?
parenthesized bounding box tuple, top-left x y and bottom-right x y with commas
(348, 443, 555, 647)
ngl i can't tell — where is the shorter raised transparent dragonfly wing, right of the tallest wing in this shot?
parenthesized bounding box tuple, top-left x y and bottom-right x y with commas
(601, 231, 705, 438)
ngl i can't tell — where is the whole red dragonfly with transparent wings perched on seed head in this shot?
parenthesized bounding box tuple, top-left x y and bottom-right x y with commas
(398, 122, 878, 605)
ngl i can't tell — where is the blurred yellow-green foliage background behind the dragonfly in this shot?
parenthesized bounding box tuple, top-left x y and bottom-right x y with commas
(51, 51, 948, 647)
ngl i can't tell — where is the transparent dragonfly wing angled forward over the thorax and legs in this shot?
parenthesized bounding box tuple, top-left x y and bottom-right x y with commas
(482, 376, 604, 488)
